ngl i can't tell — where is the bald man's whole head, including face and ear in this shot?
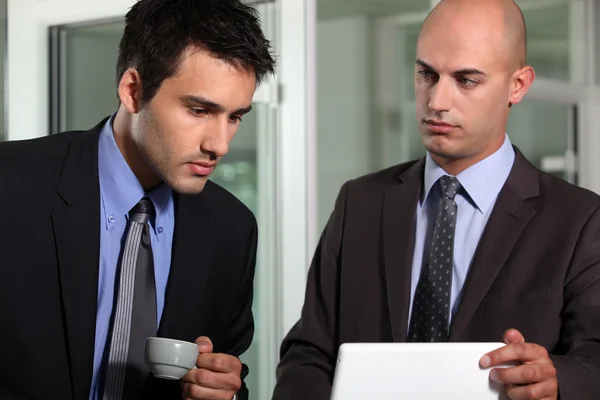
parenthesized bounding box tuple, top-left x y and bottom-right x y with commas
(415, 0, 535, 175)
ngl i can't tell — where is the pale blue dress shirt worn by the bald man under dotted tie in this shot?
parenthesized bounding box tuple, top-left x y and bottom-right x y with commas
(409, 135, 515, 326)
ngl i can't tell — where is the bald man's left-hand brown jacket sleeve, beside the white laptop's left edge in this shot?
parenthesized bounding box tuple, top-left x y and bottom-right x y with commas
(273, 182, 350, 400)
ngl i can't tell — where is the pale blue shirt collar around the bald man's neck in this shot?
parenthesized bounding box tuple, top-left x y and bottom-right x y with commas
(421, 134, 515, 213)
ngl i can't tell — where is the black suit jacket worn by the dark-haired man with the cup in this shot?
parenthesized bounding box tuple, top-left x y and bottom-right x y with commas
(0, 122, 257, 400)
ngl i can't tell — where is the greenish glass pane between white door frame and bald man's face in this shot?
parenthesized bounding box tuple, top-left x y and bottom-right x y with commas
(316, 0, 430, 231)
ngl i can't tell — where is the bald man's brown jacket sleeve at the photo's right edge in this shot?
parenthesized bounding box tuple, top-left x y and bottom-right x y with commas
(551, 205, 600, 400)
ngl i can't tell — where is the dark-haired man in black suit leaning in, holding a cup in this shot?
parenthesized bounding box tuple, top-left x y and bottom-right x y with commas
(0, 0, 274, 400)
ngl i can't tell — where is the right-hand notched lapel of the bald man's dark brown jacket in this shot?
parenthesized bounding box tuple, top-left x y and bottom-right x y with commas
(449, 150, 539, 342)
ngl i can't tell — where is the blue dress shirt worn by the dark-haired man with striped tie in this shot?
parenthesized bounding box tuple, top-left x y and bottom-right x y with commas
(89, 115, 175, 400)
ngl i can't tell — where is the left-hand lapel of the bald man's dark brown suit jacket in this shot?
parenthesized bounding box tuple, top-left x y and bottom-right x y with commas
(383, 160, 425, 342)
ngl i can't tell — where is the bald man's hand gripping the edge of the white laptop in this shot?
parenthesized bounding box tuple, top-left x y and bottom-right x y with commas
(480, 329, 558, 400)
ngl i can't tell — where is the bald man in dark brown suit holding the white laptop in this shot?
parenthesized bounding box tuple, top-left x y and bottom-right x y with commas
(273, 0, 600, 400)
